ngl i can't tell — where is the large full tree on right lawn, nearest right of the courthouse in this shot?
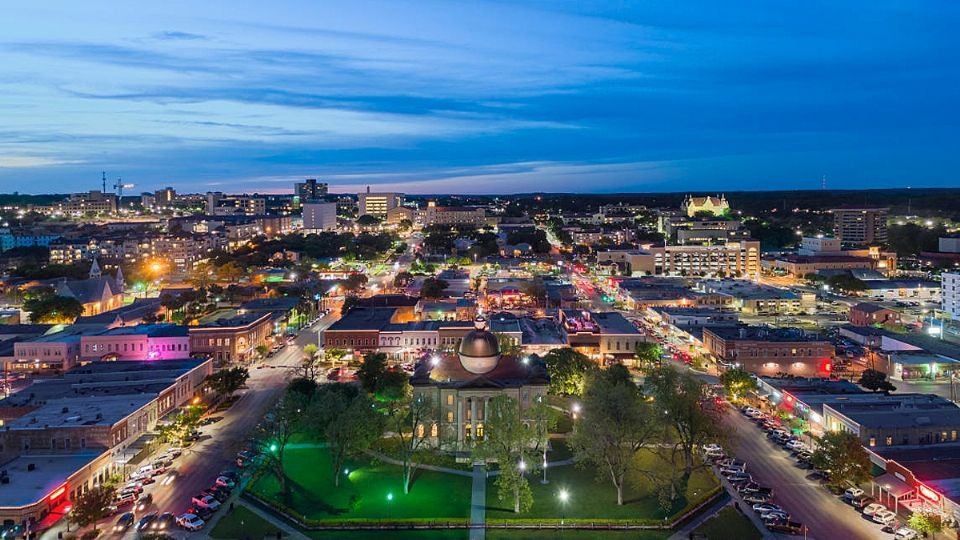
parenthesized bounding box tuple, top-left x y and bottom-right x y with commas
(570, 364, 656, 505)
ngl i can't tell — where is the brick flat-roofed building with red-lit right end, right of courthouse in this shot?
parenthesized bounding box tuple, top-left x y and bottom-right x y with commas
(703, 326, 835, 377)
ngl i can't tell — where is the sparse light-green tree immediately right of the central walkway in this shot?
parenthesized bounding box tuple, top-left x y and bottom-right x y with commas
(474, 395, 537, 513)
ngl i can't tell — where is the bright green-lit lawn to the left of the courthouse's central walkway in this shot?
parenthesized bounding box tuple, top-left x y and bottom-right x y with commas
(248, 442, 470, 521)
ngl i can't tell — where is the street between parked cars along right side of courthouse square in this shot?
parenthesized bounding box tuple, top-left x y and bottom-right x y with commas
(723, 408, 885, 540)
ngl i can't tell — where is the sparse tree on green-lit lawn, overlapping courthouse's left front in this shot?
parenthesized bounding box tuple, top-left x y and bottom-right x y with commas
(387, 384, 436, 493)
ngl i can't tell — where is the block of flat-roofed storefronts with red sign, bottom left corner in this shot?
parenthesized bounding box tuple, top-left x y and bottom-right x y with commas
(0, 360, 212, 527)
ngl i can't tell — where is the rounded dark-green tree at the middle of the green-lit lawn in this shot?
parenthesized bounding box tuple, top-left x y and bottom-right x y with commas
(310, 384, 381, 487)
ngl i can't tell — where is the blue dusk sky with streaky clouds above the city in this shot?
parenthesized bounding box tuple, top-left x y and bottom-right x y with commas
(0, 0, 960, 194)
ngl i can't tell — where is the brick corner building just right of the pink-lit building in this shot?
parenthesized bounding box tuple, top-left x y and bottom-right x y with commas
(189, 313, 273, 364)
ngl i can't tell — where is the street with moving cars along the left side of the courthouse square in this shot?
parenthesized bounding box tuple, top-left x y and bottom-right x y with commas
(41, 312, 338, 539)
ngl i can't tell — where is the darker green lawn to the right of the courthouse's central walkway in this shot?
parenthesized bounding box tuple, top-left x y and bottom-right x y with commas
(487, 450, 717, 520)
